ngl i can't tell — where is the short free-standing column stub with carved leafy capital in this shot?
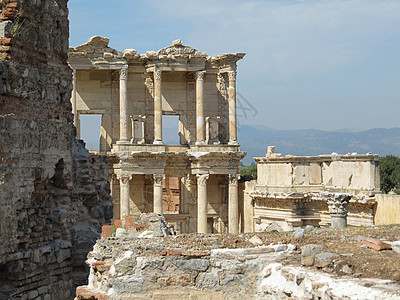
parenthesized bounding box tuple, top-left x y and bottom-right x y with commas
(324, 193, 352, 228)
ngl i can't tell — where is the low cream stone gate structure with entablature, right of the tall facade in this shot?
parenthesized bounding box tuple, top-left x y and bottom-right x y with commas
(244, 147, 380, 232)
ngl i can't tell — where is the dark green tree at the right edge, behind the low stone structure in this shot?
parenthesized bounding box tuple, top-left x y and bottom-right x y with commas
(379, 155, 400, 194)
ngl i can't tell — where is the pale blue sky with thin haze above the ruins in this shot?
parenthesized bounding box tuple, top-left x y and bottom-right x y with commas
(69, 0, 400, 130)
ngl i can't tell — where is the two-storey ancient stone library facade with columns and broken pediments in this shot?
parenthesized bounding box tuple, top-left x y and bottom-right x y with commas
(68, 36, 245, 233)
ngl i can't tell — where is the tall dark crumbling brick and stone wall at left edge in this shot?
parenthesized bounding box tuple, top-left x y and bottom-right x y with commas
(0, 0, 112, 299)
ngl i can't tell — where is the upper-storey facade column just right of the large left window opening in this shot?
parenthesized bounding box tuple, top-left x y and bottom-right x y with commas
(119, 67, 129, 142)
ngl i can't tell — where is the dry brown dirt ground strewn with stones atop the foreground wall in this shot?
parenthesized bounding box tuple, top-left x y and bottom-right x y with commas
(238, 225, 400, 283)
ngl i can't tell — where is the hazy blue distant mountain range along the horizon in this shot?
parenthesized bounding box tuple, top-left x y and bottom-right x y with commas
(238, 125, 400, 164)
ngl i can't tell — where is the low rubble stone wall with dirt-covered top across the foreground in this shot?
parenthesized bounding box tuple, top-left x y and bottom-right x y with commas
(73, 218, 400, 300)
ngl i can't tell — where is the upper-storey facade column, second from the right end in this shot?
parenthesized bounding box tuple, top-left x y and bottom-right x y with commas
(196, 71, 206, 145)
